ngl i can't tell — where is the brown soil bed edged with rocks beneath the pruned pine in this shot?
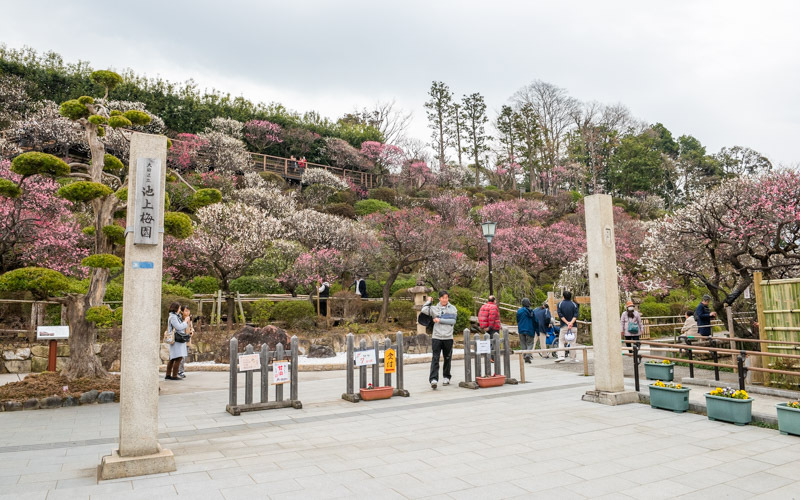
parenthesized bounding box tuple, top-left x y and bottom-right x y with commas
(0, 372, 119, 401)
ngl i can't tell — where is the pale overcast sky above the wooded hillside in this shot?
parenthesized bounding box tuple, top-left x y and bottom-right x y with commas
(0, 0, 800, 165)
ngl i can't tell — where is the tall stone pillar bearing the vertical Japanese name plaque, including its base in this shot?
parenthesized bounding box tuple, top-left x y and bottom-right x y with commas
(101, 133, 176, 479)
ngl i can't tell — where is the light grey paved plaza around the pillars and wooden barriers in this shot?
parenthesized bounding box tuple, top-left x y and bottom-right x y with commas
(0, 360, 800, 500)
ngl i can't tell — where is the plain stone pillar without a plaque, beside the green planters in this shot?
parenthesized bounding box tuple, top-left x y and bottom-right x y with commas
(583, 194, 638, 405)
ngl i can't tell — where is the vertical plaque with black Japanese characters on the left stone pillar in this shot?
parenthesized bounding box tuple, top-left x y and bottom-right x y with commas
(133, 158, 161, 245)
